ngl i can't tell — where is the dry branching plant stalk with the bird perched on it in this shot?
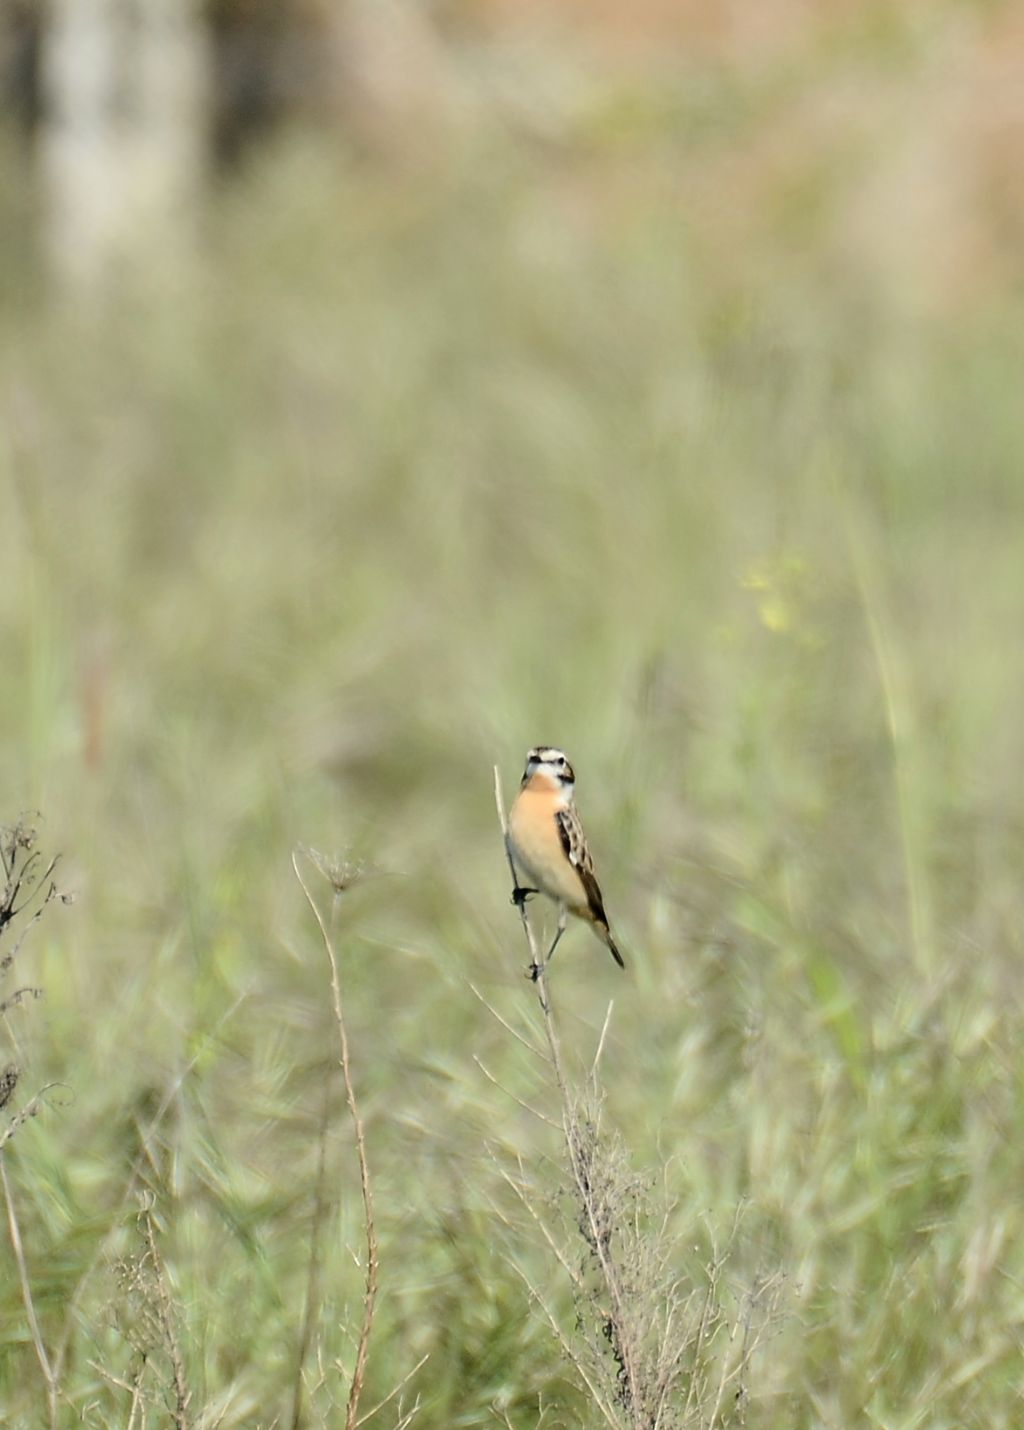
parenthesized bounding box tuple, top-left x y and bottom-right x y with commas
(485, 766, 777, 1430)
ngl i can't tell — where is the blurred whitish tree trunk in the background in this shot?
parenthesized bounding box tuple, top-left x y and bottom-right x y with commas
(40, 0, 207, 289)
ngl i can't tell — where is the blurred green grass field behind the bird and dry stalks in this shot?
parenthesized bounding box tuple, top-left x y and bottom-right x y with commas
(0, 117, 1024, 1427)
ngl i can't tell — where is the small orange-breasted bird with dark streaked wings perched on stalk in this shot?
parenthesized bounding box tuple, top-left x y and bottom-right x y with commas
(508, 745, 625, 978)
